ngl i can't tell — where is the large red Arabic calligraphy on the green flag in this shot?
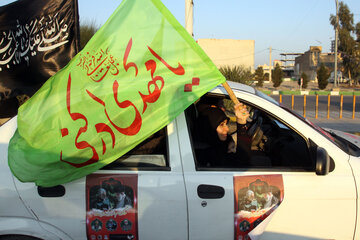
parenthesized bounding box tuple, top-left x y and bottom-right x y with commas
(60, 38, 198, 168)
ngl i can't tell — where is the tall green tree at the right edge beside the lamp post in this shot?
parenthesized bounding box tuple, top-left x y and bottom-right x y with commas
(330, 2, 360, 82)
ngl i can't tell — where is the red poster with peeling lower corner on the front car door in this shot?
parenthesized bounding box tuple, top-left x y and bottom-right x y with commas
(234, 175, 284, 240)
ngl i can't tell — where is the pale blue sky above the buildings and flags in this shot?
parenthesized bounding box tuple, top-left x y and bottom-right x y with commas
(0, 0, 360, 68)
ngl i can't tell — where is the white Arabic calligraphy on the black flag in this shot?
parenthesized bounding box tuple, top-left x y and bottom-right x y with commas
(0, 13, 69, 71)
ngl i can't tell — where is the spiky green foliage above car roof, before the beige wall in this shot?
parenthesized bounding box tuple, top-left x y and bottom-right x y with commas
(219, 66, 253, 85)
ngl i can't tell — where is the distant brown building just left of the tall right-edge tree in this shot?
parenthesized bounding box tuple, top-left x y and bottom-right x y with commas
(294, 46, 341, 81)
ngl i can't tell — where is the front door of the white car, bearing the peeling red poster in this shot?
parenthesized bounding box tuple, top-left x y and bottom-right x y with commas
(177, 92, 356, 239)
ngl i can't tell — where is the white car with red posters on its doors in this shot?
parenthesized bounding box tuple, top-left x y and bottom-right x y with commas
(0, 83, 360, 240)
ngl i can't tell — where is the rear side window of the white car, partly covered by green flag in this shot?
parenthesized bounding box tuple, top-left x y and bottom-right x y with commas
(103, 127, 169, 170)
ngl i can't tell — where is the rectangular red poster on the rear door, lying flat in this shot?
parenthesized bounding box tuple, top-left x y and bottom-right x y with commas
(86, 174, 138, 240)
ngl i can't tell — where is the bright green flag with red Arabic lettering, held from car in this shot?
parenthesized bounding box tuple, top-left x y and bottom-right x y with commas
(8, 0, 225, 186)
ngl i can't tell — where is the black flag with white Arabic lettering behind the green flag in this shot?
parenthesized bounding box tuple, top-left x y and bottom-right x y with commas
(0, 0, 80, 119)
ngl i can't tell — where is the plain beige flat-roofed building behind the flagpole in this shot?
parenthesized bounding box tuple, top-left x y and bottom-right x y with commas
(197, 39, 255, 72)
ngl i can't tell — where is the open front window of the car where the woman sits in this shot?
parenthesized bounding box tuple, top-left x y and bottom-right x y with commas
(185, 94, 315, 171)
